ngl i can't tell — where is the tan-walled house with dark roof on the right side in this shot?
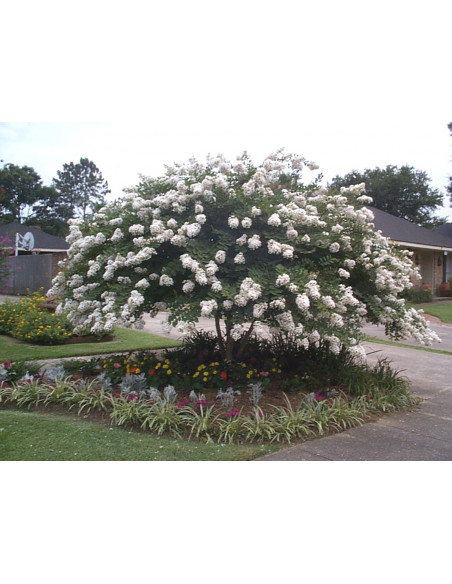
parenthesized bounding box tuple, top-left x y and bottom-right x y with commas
(369, 207, 452, 295)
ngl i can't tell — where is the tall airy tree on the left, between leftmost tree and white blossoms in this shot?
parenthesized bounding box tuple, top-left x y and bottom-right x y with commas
(52, 158, 110, 220)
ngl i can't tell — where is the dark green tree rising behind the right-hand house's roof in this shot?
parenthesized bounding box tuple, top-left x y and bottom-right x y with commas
(329, 165, 443, 228)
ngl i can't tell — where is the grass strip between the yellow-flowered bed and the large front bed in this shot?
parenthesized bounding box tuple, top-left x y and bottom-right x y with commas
(0, 327, 181, 362)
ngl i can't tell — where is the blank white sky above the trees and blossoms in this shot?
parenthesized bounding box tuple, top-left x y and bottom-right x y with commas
(0, 0, 452, 216)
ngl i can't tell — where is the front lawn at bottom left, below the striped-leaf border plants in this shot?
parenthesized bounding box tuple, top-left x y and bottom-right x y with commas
(0, 410, 281, 461)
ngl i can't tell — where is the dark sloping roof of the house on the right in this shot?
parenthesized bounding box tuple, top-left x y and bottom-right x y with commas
(369, 207, 452, 251)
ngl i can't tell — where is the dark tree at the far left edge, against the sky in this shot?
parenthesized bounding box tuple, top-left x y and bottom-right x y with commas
(0, 164, 43, 223)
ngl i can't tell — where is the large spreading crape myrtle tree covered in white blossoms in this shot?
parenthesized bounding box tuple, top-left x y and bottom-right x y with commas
(49, 151, 437, 361)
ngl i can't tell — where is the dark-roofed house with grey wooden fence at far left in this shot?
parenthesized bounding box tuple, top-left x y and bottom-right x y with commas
(0, 223, 69, 294)
